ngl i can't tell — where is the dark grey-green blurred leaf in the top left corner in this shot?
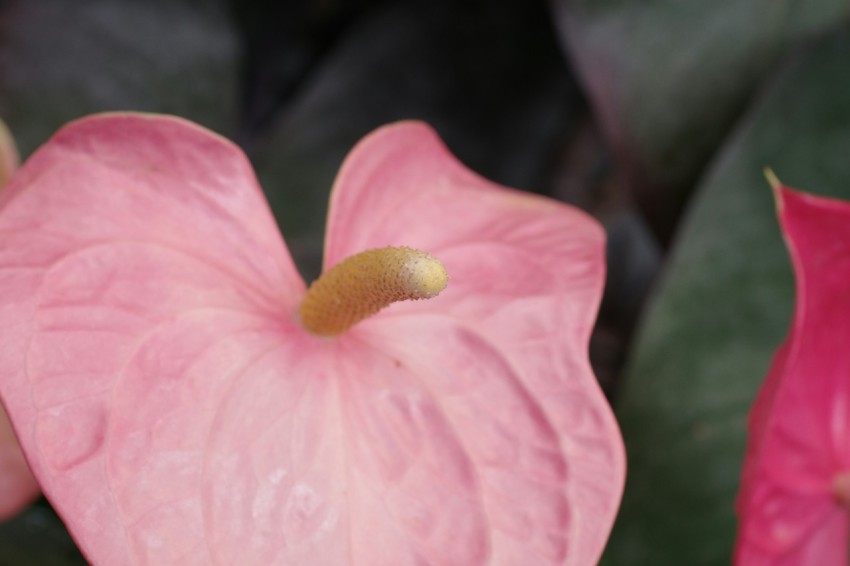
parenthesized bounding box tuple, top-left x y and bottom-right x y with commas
(0, 0, 237, 156)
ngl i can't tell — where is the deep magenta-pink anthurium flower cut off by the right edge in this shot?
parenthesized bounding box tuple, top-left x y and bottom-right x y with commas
(735, 177, 850, 566)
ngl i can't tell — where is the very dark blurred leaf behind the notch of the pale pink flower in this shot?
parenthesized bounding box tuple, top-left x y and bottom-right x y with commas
(249, 2, 580, 280)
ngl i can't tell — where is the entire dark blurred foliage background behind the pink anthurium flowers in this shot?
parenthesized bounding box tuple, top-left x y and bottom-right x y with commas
(0, 0, 850, 566)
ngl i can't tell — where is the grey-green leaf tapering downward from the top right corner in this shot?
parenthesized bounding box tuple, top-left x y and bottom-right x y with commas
(555, 0, 850, 234)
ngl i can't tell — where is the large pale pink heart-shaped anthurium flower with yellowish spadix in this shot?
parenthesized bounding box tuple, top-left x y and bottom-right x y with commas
(0, 114, 624, 566)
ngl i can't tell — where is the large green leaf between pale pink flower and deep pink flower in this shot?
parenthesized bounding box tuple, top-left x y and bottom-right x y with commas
(604, 27, 850, 566)
